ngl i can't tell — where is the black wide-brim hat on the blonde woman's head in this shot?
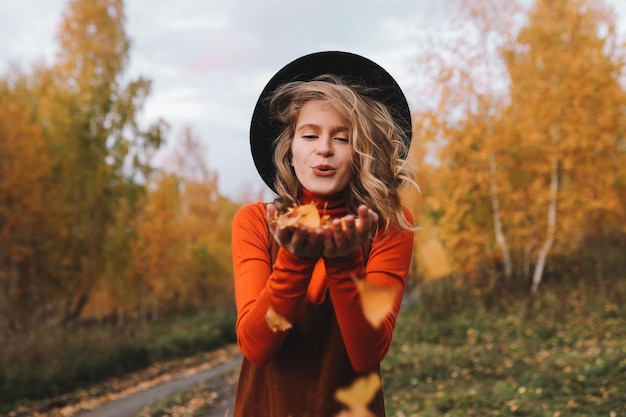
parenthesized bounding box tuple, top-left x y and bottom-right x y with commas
(250, 51, 413, 191)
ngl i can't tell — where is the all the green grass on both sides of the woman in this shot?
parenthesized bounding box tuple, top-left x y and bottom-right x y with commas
(0, 272, 626, 417)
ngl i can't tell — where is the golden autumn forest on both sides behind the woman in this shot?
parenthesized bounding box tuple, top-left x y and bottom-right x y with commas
(0, 0, 626, 410)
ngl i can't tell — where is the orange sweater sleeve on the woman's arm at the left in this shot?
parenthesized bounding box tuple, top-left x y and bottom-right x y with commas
(232, 203, 316, 365)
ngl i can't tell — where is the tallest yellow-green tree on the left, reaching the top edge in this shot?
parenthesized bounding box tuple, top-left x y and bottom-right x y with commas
(29, 0, 165, 322)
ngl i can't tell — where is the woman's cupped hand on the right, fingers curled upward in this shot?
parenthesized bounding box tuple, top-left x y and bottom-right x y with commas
(322, 205, 378, 258)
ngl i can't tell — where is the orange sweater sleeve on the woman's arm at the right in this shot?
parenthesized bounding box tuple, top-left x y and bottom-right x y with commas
(325, 210, 413, 372)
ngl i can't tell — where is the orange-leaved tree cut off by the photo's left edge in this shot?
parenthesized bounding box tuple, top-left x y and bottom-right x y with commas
(0, 74, 48, 332)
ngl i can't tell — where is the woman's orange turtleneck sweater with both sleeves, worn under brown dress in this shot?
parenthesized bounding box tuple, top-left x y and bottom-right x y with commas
(232, 190, 413, 373)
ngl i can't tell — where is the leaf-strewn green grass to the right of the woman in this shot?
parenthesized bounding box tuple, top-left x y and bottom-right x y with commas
(383, 276, 626, 417)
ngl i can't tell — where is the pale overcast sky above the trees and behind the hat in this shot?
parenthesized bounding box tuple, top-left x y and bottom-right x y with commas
(0, 0, 626, 198)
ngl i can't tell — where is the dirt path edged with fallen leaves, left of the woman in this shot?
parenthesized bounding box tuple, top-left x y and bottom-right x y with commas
(9, 343, 242, 417)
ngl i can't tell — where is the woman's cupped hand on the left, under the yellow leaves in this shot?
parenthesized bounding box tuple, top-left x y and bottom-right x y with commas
(266, 203, 324, 258)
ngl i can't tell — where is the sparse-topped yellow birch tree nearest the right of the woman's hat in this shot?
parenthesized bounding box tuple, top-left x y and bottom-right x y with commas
(416, 0, 519, 279)
